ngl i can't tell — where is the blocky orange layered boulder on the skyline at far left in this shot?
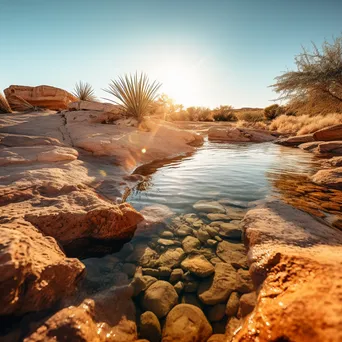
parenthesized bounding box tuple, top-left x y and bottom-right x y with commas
(4, 85, 76, 111)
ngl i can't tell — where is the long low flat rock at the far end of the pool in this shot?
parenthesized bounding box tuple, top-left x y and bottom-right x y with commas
(208, 127, 276, 142)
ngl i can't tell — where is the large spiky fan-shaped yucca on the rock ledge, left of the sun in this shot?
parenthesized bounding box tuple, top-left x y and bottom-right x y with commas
(104, 72, 161, 121)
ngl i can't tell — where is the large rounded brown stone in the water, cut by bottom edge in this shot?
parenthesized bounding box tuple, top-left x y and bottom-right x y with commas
(162, 304, 212, 342)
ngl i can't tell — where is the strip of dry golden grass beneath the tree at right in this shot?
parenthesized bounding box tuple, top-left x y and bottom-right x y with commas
(269, 113, 342, 135)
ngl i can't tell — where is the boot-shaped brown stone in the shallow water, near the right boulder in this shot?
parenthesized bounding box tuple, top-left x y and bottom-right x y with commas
(198, 263, 236, 305)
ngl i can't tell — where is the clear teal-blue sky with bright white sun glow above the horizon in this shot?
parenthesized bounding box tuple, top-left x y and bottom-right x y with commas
(0, 0, 342, 108)
